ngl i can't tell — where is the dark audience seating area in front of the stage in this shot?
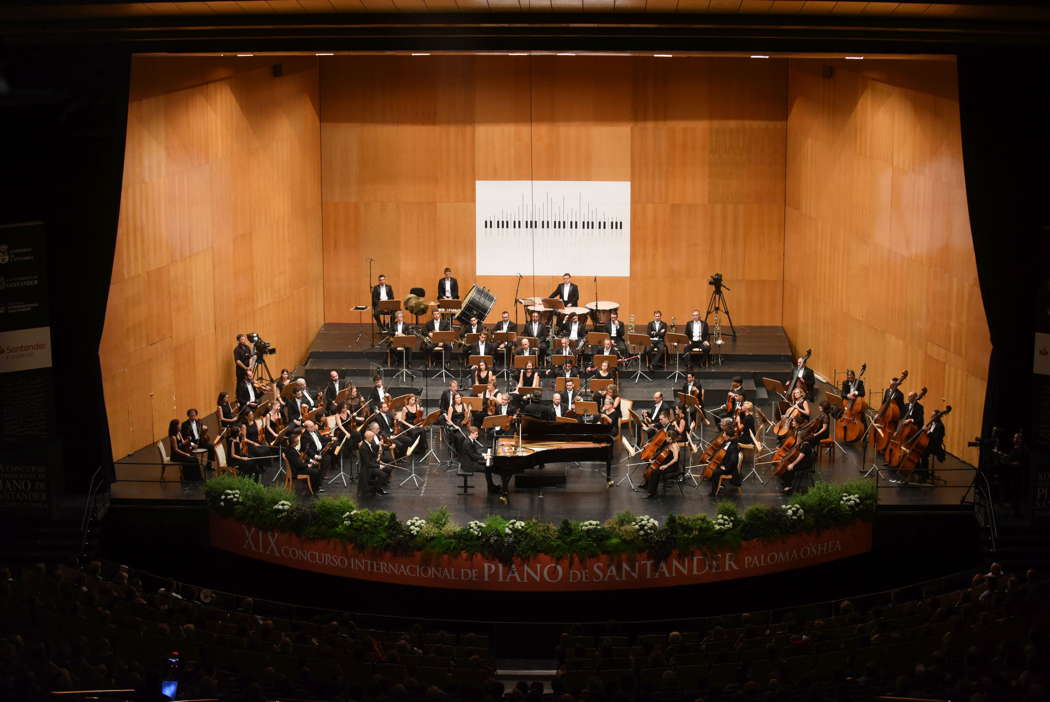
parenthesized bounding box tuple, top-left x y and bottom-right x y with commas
(0, 562, 1050, 702)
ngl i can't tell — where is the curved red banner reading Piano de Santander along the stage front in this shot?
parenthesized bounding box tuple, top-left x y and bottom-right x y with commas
(211, 514, 872, 592)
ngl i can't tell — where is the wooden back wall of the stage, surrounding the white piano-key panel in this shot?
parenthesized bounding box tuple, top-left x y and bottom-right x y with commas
(320, 56, 786, 324)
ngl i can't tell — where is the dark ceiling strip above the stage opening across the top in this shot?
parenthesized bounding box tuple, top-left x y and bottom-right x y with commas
(0, 0, 1050, 54)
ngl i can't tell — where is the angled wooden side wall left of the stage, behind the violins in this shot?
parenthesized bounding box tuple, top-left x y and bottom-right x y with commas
(100, 58, 323, 458)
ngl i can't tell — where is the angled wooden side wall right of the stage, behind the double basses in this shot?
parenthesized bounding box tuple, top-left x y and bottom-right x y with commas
(783, 61, 991, 462)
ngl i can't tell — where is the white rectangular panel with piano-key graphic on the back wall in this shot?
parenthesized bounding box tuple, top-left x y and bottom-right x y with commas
(475, 180, 631, 276)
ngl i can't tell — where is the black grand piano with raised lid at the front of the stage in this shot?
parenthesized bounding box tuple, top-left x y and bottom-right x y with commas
(492, 414, 614, 488)
